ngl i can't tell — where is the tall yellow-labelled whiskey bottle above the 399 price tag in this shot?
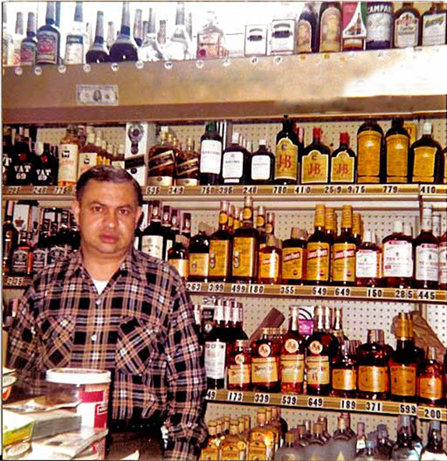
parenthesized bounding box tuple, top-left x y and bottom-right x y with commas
(208, 200, 233, 282)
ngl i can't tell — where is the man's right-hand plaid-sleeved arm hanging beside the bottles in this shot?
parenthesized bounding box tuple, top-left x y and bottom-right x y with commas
(165, 274, 207, 460)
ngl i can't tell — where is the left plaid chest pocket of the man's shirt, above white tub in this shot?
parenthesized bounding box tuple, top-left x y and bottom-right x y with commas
(40, 315, 75, 368)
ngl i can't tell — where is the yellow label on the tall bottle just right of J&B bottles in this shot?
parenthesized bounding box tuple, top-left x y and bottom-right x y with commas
(357, 130, 382, 183)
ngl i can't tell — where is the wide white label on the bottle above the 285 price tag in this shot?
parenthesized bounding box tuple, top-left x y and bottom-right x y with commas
(383, 240, 413, 277)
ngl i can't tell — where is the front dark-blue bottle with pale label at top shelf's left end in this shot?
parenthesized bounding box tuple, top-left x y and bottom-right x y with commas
(36, 2, 61, 66)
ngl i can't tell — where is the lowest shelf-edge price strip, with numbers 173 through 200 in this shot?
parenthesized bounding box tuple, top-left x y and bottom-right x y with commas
(206, 389, 447, 422)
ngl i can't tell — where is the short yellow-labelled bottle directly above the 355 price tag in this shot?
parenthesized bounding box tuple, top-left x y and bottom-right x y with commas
(281, 227, 307, 285)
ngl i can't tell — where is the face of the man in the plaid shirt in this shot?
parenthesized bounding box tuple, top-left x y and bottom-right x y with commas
(73, 180, 141, 259)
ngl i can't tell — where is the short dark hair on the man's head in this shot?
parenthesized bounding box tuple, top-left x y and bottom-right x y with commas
(76, 165, 143, 206)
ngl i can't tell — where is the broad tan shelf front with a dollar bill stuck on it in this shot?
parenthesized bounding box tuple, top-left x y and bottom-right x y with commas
(3, 45, 447, 124)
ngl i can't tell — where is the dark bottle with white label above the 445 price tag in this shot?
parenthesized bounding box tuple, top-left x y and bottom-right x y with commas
(413, 204, 439, 290)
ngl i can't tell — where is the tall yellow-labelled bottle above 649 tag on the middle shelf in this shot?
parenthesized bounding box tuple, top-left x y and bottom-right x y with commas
(332, 205, 357, 285)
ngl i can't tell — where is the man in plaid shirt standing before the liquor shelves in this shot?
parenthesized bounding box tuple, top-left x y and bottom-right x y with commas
(9, 165, 206, 460)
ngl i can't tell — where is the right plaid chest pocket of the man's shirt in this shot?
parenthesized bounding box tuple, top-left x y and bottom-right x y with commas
(115, 317, 160, 375)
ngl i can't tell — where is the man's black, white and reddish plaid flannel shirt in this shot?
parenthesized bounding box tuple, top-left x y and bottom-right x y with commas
(9, 249, 206, 460)
